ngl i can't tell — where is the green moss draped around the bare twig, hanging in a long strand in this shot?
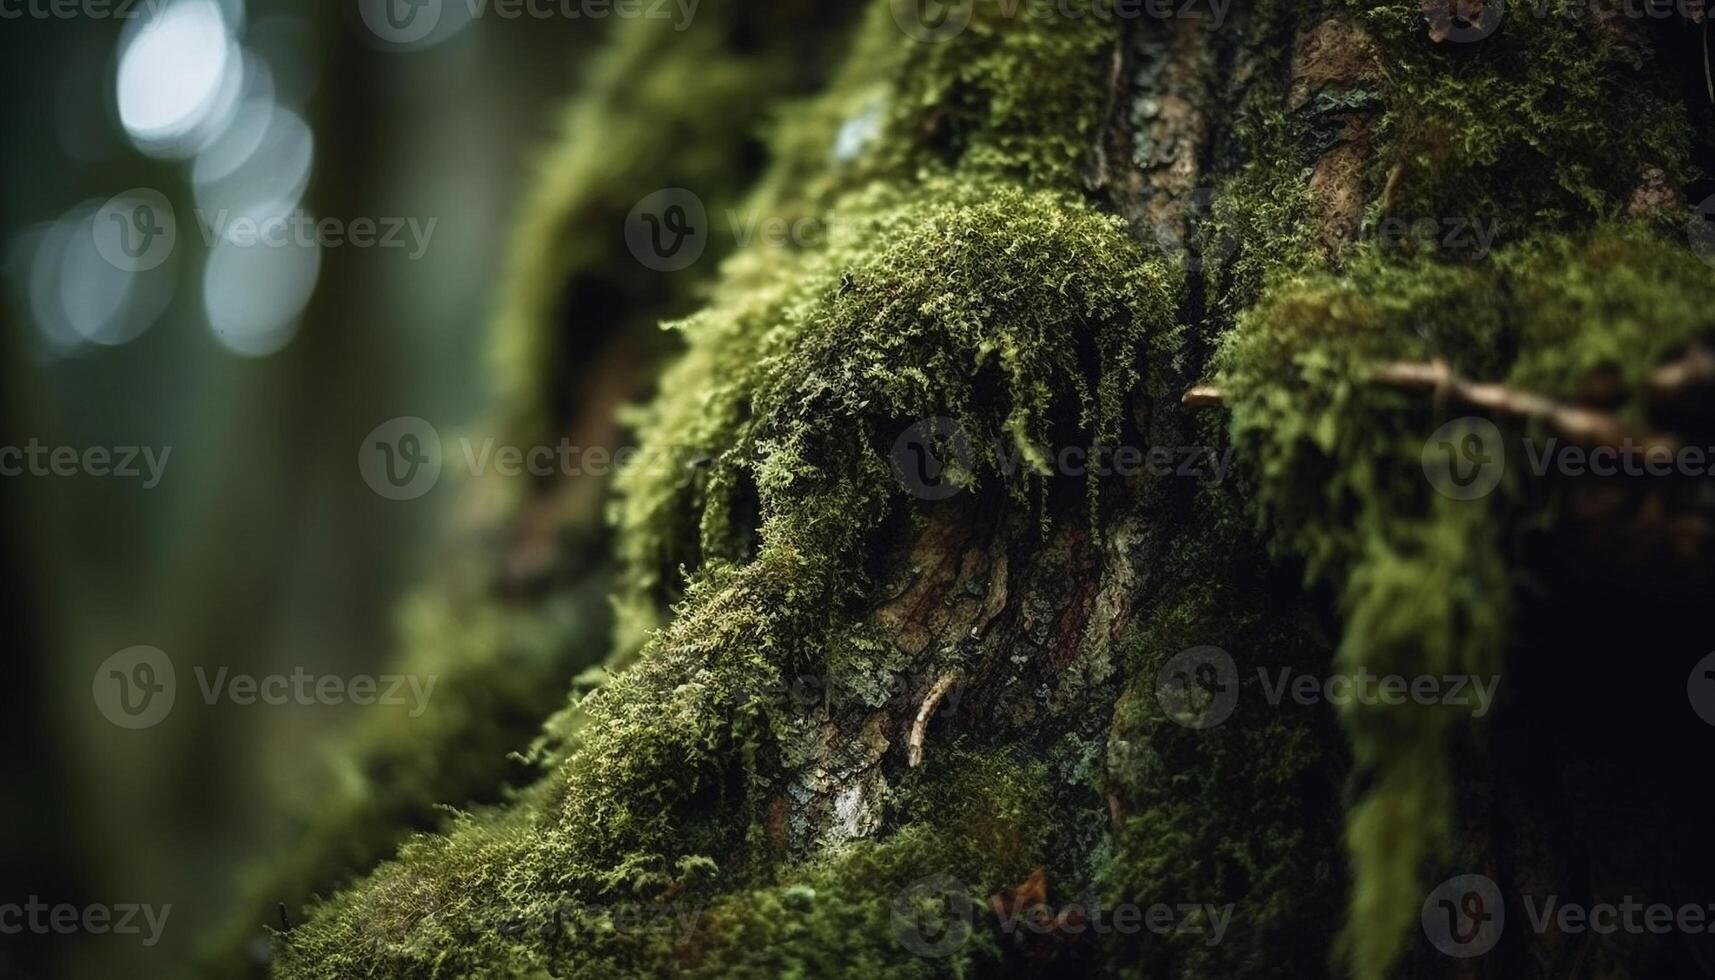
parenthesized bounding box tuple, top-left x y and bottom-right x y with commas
(1219, 227, 1715, 978)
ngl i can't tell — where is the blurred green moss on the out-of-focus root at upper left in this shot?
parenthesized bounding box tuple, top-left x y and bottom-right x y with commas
(490, 0, 871, 439)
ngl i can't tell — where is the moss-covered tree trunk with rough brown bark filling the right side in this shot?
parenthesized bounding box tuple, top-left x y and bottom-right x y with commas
(210, 0, 1715, 978)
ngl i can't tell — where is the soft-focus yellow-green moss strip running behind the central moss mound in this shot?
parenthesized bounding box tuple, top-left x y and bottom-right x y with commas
(617, 2, 1164, 637)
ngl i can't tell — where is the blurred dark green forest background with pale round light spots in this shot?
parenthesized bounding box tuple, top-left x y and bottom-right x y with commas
(0, 0, 611, 977)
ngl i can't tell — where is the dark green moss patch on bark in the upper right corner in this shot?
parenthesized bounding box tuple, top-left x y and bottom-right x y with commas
(1334, 0, 1691, 235)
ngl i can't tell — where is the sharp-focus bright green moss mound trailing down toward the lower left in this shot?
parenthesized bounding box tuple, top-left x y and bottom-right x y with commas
(277, 164, 1173, 975)
